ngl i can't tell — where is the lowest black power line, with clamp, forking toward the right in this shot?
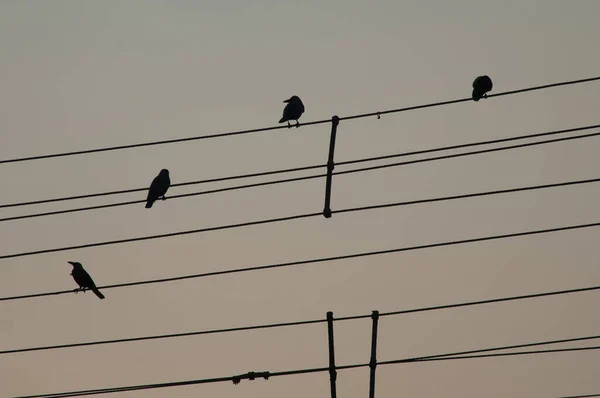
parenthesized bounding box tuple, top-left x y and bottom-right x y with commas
(19, 336, 600, 398)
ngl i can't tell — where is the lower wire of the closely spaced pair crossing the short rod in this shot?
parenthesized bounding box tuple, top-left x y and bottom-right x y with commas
(0, 132, 600, 222)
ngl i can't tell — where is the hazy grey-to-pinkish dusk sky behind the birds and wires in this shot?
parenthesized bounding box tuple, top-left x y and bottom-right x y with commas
(0, 0, 600, 398)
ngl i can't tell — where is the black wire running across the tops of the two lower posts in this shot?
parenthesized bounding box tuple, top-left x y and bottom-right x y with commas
(0, 286, 600, 355)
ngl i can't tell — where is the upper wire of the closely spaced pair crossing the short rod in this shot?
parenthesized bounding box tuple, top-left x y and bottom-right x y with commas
(0, 124, 600, 208)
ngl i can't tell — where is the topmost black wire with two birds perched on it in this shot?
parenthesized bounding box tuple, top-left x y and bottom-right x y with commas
(0, 76, 600, 164)
